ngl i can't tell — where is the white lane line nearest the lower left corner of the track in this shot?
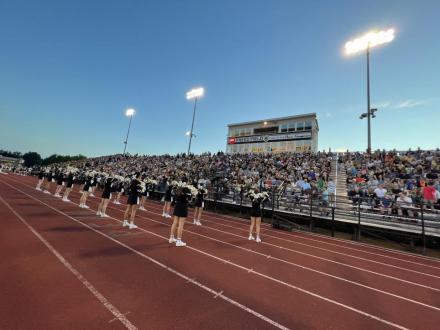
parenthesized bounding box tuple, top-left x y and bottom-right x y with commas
(0, 196, 137, 330)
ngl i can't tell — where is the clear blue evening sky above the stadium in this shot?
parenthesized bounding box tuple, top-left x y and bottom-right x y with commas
(0, 0, 440, 156)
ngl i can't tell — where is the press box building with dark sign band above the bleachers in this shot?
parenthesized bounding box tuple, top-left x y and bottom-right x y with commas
(226, 113, 319, 154)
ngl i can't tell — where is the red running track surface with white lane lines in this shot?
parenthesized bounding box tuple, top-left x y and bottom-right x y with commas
(0, 175, 440, 330)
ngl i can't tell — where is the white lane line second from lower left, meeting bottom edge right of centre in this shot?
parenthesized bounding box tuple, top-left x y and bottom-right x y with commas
(0, 180, 292, 330)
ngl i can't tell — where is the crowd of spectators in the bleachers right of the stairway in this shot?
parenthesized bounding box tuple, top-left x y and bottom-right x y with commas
(339, 150, 440, 217)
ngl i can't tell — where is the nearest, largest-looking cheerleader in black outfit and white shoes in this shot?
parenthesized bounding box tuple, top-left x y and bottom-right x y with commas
(169, 179, 191, 246)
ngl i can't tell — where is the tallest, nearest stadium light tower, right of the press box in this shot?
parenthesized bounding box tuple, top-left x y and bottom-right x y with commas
(345, 29, 394, 153)
